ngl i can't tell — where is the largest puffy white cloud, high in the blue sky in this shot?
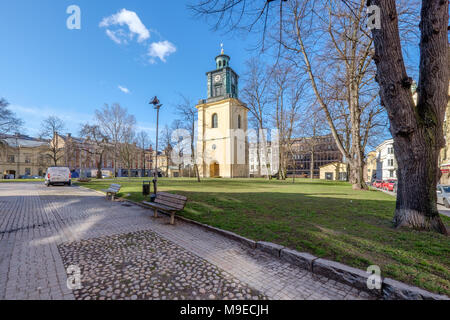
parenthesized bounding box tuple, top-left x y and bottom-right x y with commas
(99, 9, 150, 44)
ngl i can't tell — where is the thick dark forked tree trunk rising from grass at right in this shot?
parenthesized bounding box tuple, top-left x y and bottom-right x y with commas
(369, 0, 449, 234)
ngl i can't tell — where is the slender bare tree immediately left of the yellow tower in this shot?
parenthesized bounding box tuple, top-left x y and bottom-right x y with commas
(177, 95, 200, 182)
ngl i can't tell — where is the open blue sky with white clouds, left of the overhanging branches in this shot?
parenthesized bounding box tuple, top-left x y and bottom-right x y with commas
(0, 0, 252, 137)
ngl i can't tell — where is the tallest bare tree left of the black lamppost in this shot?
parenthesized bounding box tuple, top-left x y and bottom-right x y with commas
(95, 103, 136, 177)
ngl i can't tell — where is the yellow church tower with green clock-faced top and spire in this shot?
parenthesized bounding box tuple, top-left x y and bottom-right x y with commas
(196, 46, 249, 178)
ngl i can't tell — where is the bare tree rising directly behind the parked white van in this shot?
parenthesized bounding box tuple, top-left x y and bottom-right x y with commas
(39, 116, 65, 166)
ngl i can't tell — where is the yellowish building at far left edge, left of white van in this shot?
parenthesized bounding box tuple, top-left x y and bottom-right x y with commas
(0, 134, 50, 179)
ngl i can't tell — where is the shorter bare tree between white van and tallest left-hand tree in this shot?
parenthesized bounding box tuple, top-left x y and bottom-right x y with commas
(80, 123, 109, 179)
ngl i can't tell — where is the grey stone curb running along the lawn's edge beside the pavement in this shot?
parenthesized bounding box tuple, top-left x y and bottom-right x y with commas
(74, 186, 450, 300)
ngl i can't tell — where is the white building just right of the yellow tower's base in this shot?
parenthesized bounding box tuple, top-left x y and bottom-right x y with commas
(248, 141, 279, 177)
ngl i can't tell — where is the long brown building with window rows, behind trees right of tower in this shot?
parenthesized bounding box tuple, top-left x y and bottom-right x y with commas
(287, 134, 346, 180)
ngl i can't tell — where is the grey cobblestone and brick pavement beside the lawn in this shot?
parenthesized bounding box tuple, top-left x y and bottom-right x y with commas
(0, 183, 373, 299)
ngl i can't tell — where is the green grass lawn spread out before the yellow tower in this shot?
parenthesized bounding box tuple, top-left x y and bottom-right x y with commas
(80, 178, 450, 295)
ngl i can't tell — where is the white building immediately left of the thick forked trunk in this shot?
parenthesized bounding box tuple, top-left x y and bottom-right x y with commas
(375, 139, 397, 180)
